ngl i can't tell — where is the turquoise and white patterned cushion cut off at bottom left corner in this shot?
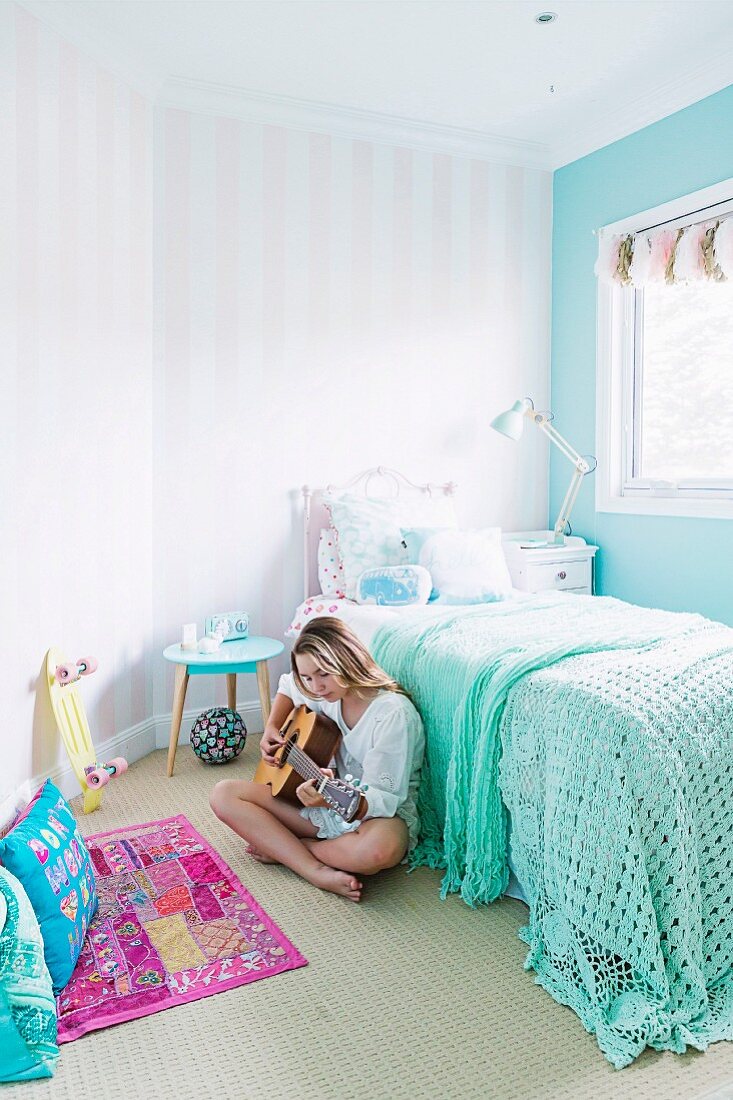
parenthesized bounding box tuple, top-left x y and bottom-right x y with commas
(0, 867, 58, 1082)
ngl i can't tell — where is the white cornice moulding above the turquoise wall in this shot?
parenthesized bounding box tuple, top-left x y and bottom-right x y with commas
(550, 50, 733, 171)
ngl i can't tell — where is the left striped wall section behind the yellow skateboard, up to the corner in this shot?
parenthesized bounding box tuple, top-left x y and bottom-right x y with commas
(0, 3, 152, 794)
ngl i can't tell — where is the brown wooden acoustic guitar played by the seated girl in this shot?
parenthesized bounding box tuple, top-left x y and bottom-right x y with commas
(254, 706, 367, 822)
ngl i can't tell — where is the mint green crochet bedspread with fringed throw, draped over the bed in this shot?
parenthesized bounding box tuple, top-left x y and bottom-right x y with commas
(372, 594, 733, 1067)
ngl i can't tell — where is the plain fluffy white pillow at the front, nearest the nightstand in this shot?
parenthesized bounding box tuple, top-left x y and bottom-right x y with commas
(403, 527, 512, 604)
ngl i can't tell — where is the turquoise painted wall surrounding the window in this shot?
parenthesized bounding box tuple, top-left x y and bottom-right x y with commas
(550, 85, 733, 625)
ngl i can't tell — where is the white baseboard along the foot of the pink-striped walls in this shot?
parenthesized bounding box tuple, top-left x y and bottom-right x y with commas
(31, 701, 267, 805)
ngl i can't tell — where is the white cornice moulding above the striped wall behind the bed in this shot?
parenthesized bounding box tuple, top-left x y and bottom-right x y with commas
(155, 77, 550, 172)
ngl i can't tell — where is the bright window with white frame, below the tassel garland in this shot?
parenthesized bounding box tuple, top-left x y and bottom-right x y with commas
(597, 180, 733, 517)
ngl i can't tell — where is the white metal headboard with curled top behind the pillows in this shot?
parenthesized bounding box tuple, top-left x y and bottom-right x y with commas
(302, 466, 456, 598)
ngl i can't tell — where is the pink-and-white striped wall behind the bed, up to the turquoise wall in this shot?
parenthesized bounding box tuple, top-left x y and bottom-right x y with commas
(153, 109, 551, 712)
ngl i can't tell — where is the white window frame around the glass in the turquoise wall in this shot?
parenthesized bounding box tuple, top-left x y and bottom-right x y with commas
(595, 179, 733, 517)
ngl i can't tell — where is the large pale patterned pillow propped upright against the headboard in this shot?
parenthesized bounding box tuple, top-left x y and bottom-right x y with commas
(324, 493, 457, 600)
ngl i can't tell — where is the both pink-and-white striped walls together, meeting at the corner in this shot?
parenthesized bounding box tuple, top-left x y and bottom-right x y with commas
(0, 4, 551, 795)
